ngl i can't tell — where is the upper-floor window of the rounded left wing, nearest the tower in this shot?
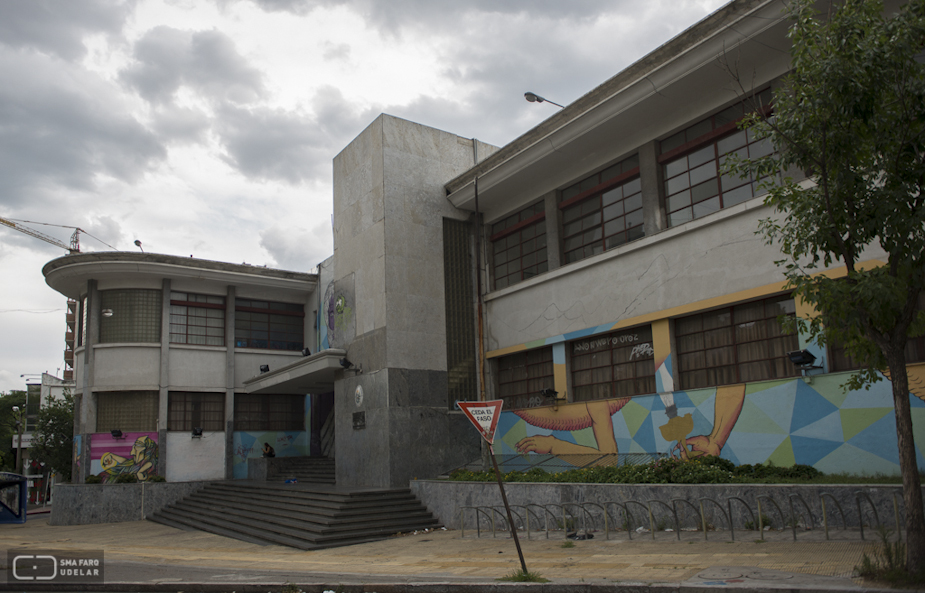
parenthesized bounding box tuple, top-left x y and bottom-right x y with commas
(234, 299, 305, 351)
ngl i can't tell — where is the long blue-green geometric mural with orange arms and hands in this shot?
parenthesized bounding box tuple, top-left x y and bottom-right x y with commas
(495, 366, 925, 475)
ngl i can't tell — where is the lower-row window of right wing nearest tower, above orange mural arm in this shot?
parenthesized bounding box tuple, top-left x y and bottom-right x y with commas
(498, 347, 555, 410)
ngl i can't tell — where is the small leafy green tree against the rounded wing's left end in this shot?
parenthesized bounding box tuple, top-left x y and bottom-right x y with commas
(30, 389, 74, 481)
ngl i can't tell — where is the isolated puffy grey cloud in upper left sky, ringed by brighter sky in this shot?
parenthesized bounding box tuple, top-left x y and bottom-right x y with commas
(120, 26, 266, 104)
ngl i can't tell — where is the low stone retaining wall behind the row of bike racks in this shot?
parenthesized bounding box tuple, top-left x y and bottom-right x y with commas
(411, 480, 903, 529)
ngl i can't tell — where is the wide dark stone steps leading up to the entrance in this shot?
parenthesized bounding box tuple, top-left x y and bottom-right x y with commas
(149, 481, 440, 550)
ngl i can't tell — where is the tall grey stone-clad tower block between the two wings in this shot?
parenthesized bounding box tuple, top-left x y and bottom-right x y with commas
(333, 115, 494, 487)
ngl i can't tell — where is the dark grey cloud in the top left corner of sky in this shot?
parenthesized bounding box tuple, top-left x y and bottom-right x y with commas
(0, 0, 136, 60)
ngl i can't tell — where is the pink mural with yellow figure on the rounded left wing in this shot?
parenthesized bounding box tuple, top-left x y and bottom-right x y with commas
(90, 432, 158, 482)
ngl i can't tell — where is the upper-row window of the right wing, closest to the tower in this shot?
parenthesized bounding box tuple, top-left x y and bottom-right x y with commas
(491, 200, 549, 289)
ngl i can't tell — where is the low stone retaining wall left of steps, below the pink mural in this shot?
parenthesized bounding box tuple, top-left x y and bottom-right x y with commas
(48, 482, 209, 525)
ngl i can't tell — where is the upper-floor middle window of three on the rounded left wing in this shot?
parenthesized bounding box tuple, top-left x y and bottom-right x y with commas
(170, 292, 225, 346)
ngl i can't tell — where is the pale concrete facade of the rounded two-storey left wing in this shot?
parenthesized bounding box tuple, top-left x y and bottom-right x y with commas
(43, 252, 319, 482)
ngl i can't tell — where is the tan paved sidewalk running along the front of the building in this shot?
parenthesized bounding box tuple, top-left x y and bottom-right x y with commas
(0, 515, 904, 593)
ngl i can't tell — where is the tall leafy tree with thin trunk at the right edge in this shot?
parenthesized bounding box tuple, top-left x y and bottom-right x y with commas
(727, 0, 925, 572)
